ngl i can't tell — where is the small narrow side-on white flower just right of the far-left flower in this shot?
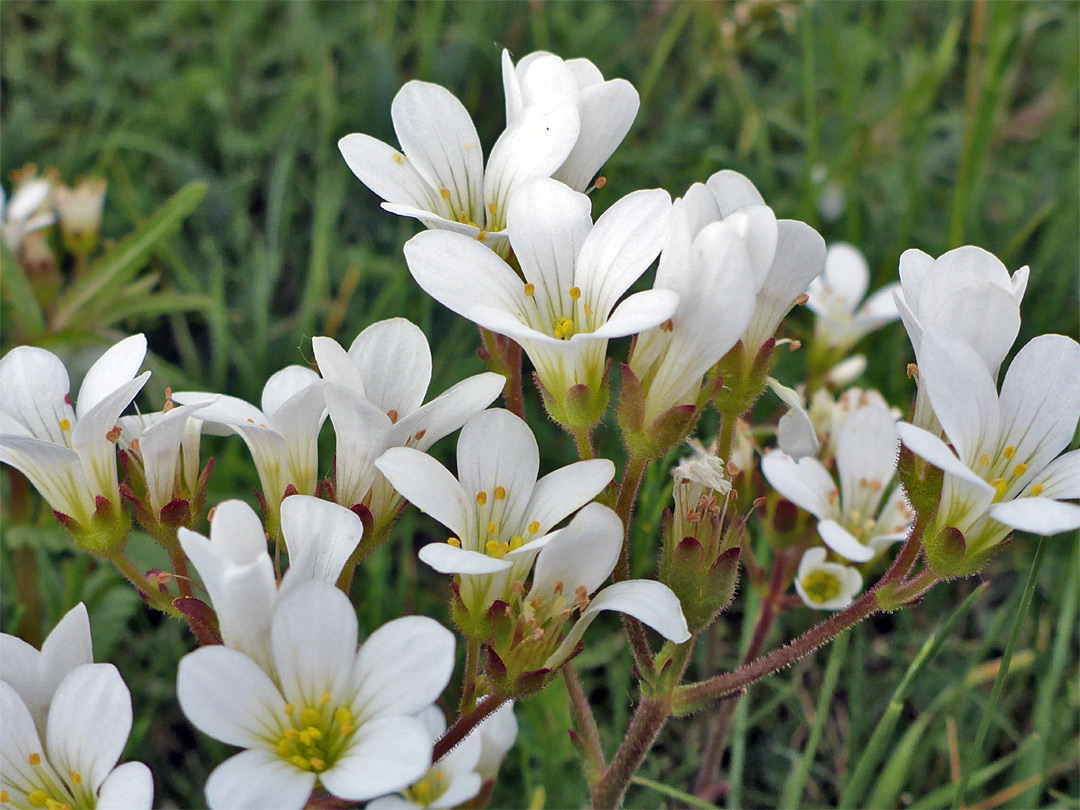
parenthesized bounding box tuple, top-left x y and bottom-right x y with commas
(118, 402, 210, 515)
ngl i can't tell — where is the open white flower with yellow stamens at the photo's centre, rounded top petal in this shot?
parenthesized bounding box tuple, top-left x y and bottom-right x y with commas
(375, 408, 615, 617)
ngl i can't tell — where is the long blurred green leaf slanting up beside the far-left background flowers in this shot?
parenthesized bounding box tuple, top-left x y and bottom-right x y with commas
(52, 181, 207, 329)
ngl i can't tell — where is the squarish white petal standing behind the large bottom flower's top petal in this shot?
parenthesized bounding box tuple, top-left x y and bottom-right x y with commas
(281, 495, 364, 593)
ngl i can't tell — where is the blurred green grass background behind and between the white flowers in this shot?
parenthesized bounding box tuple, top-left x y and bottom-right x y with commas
(0, 1, 1080, 807)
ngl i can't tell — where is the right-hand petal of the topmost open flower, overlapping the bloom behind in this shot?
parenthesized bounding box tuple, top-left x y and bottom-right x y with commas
(483, 104, 580, 230)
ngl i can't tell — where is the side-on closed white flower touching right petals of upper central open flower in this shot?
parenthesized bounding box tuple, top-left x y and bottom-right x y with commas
(630, 184, 758, 424)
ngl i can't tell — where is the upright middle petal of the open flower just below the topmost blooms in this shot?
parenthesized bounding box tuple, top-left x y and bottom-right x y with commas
(507, 177, 593, 321)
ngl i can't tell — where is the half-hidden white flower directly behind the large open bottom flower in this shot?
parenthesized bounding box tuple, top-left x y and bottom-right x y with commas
(177, 495, 364, 669)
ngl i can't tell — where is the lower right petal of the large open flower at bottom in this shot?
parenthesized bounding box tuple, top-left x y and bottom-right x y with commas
(320, 715, 431, 801)
